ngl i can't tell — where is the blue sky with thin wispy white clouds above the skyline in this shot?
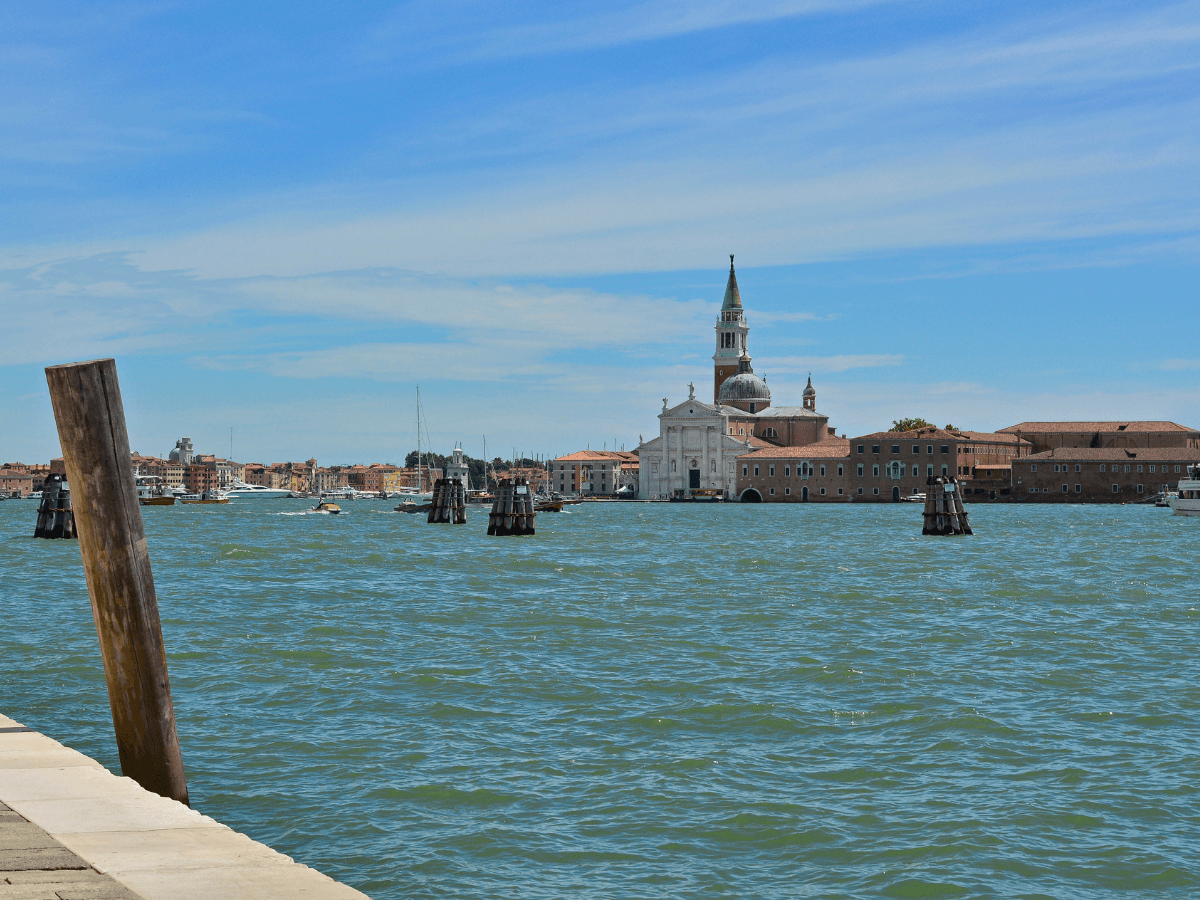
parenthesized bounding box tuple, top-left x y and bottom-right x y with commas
(0, 0, 1200, 464)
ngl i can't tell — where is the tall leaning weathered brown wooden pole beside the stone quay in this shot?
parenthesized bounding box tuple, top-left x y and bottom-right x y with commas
(46, 359, 187, 803)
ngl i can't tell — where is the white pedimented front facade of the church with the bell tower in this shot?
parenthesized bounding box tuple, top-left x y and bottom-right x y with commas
(637, 384, 749, 499)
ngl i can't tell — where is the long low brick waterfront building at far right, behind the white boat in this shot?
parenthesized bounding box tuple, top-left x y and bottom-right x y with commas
(1012, 446, 1200, 503)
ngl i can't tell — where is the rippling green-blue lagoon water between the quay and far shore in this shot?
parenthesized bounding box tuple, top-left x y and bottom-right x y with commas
(0, 500, 1200, 899)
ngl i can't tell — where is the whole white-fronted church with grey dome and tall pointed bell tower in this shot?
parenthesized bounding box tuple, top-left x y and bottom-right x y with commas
(637, 254, 835, 499)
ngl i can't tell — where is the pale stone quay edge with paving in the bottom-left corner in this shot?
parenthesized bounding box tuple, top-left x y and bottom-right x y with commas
(0, 714, 366, 900)
